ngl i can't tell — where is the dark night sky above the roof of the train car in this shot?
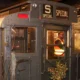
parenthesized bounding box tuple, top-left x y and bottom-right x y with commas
(0, 0, 80, 9)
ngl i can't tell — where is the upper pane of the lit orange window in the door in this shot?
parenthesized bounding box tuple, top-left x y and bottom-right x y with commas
(47, 30, 64, 44)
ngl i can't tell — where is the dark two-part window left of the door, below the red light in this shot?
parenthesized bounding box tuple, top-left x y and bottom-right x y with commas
(11, 27, 36, 53)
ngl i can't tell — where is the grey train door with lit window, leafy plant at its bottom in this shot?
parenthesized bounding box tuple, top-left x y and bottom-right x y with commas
(43, 25, 69, 80)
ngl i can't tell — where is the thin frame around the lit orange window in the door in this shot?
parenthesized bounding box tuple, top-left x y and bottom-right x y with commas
(45, 28, 67, 61)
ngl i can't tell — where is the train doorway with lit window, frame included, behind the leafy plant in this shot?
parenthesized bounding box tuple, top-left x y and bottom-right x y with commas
(42, 24, 70, 80)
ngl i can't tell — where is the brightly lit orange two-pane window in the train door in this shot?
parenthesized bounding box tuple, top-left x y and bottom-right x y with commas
(46, 30, 65, 59)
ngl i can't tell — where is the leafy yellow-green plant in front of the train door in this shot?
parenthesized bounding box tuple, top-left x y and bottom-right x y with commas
(49, 61, 68, 80)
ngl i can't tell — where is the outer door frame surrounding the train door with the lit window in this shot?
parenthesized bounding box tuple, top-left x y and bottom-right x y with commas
(42, 23, 72, 80)
